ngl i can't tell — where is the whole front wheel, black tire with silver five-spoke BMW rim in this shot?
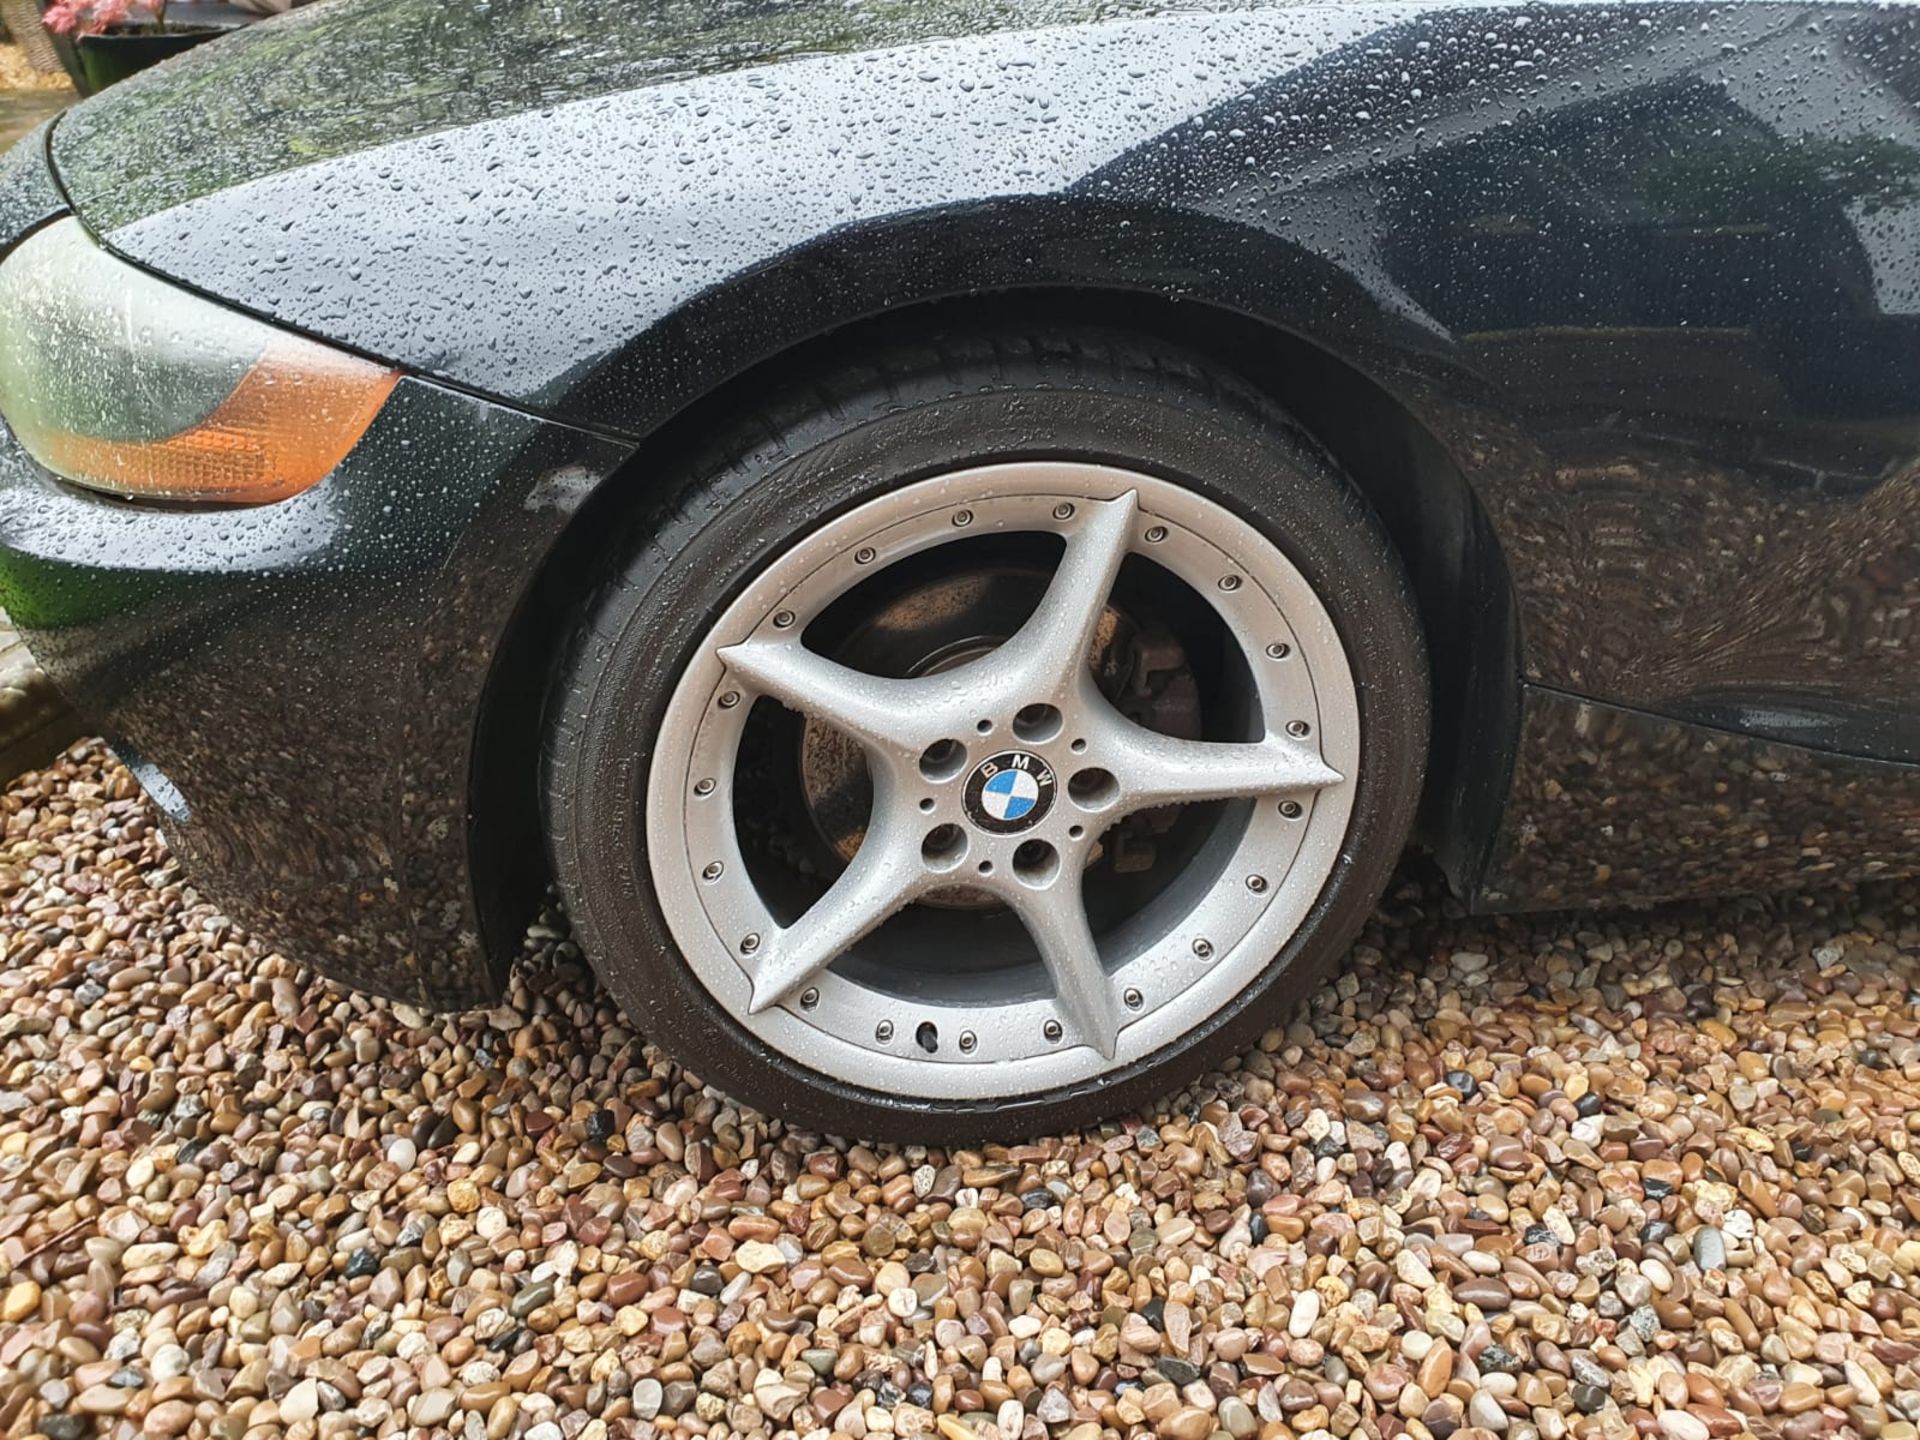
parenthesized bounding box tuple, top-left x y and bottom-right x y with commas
(545, 336, 1427, 1142)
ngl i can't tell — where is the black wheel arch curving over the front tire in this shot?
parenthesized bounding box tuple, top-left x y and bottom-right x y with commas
(468, 286, 1521, 971)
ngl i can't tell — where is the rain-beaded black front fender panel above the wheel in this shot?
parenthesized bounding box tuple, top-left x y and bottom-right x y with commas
(56, 4, 1920, 758)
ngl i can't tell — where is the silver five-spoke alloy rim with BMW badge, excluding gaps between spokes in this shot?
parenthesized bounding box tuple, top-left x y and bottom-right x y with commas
(645, 463, 1361, 1100)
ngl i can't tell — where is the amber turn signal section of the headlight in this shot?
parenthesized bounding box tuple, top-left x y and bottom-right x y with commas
(35, 340, 399, 505)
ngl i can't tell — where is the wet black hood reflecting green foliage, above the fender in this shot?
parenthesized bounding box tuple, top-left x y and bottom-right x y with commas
(54, 0, 1198, 232)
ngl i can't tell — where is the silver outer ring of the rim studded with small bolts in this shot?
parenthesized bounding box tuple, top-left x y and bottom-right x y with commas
(645, 461, 1361, 1102)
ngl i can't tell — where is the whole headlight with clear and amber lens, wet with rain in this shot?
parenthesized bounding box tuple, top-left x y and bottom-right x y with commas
(0, 219, 399, 505)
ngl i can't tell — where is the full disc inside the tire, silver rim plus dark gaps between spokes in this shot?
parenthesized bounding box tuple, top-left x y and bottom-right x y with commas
(647, 463, 1359, 1098)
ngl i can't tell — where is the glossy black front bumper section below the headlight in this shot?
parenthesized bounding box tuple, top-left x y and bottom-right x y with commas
(0, 380, 624, 1004)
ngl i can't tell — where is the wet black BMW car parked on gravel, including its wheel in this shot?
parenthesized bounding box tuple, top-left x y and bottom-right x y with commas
(0, 0, 1920, 1140)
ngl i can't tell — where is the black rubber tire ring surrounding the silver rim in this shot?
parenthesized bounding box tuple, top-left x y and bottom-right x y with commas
(545, 359, 1427, 1142)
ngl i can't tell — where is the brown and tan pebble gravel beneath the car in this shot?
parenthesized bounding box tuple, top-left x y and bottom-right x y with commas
(0, 747, 1920, 1440)
